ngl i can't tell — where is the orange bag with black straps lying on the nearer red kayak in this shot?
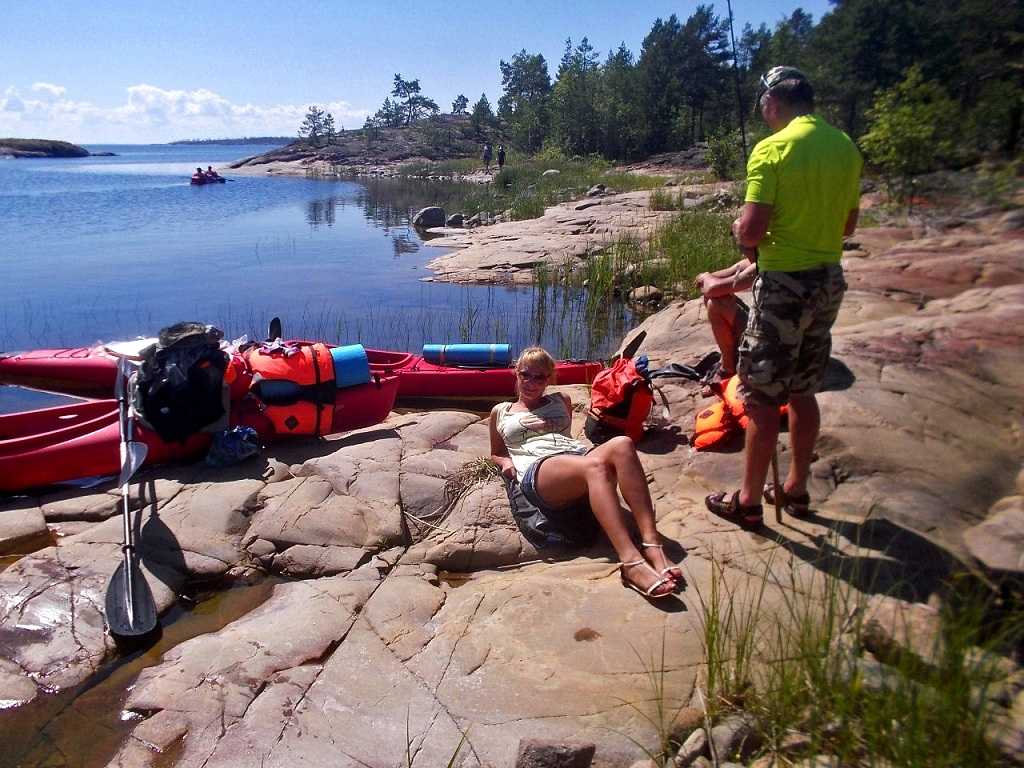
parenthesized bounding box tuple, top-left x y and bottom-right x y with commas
(246, 342, 334, 435)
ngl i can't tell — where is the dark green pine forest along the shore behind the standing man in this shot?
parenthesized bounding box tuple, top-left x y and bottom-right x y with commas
(356, 0, 1024, 172)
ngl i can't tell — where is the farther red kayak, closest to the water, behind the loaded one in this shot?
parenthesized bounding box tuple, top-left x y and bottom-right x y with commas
(0, 345, 603, 400)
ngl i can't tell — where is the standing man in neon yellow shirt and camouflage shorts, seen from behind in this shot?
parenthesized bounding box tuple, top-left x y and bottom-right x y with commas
(705, 67, 861, 526)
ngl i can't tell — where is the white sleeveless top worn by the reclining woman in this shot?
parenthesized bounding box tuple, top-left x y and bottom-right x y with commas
(497, 394, 587, 482)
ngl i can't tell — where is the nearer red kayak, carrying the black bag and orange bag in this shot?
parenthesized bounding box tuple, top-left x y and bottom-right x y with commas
(0, 376, 398, 493)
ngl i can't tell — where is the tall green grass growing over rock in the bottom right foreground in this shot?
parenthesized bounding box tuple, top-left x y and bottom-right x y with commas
(697, 548, 1024, 768)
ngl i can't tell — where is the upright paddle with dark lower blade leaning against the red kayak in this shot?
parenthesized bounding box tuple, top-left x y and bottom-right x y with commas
(104, 357, 157, 637)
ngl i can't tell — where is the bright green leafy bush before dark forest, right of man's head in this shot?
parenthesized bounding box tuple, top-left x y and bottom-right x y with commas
(860, 65, 959, 202)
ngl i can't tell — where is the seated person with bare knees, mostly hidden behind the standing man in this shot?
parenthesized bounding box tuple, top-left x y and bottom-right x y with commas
(694, 251, 758, 394)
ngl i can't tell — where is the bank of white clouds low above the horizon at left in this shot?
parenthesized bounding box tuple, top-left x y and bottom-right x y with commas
(0, 83, 370, 143)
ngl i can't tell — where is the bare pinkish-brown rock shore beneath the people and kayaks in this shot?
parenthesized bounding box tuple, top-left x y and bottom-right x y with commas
(0, 185, 1024, 768)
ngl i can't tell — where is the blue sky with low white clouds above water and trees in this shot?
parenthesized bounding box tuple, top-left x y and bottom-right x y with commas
(0, 0, 828, 144)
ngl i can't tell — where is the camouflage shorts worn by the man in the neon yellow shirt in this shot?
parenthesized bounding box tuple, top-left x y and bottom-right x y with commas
(737, 264, 846, 406)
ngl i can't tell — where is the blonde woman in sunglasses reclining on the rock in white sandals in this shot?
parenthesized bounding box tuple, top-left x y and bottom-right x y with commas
(490, 347, 683, 598)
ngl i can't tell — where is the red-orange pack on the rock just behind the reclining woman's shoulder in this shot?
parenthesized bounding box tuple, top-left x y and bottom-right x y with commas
(586, 357, 654, 443)
